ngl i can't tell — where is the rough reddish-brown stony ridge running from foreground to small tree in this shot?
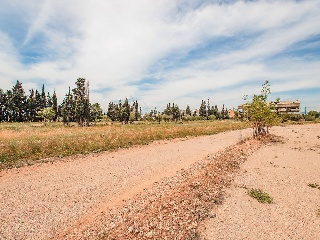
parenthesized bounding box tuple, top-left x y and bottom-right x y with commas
(59, 136, 277, 239)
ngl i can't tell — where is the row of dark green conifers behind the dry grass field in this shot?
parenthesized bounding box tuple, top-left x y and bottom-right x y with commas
(0, 78, 229, 126)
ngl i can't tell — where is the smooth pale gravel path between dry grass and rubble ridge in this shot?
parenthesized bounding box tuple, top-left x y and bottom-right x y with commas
(0, 129, 251, 239)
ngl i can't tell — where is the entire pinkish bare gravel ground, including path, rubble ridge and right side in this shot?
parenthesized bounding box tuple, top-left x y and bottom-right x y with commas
(0, 125, 320, 239)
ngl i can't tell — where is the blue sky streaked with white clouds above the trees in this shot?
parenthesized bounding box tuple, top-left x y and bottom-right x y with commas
(0, 0, 320, 112)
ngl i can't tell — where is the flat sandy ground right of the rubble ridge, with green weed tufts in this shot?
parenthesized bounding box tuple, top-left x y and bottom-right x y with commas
(201, 124, 320, 240)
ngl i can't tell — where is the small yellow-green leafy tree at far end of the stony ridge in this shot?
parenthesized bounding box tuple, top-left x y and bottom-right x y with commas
(243, 81, 279, 136)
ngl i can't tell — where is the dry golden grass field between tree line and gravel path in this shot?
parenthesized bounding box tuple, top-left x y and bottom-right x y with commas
(0, 121, 248, 169)
